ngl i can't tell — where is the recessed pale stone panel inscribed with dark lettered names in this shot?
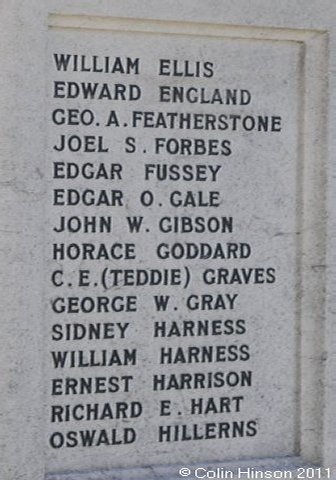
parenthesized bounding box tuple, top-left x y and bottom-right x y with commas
(45, 22, 301, 469)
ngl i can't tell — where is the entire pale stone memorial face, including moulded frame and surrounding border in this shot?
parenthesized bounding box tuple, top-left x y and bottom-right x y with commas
(0, 0, 336, 480)
